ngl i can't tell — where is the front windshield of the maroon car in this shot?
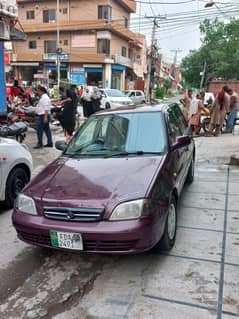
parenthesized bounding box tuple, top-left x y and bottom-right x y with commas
(64, 112, 166, 157)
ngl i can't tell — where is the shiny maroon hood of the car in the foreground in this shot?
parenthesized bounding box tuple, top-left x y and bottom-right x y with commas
(26, 156, 162, 211)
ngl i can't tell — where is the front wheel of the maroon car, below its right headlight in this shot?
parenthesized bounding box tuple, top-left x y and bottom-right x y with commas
(155, 196, 177, 250)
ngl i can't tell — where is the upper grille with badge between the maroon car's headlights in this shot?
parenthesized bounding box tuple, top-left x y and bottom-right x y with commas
(44, 207, 104, 222)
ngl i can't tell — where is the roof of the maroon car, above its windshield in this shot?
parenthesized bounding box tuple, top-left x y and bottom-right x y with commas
(97, 102, 178, 115)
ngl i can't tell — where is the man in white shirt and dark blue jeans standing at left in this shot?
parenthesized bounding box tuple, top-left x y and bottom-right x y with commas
(34, 86, 53, 148)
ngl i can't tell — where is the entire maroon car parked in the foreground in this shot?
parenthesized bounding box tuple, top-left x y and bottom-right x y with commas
(13, 103, 195, 254)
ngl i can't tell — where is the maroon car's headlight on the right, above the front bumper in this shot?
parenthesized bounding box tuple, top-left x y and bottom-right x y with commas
(110, 199, 144, 220)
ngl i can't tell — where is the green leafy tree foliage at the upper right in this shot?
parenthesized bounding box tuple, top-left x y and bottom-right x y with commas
(181, 20, 239, 87)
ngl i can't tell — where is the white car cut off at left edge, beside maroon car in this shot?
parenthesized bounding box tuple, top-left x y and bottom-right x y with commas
(0, 137, 33, 208)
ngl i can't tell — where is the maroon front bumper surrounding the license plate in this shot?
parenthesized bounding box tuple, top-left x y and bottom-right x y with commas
(13, 210, 158, 254)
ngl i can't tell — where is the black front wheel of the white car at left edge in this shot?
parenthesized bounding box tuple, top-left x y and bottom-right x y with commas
(4, 167, 29, 208)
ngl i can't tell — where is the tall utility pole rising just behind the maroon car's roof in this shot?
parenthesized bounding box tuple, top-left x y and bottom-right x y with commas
(147, 18, 159, 102)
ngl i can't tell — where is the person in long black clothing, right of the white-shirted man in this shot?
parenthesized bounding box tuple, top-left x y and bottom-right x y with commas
(58, 86, 77, 144)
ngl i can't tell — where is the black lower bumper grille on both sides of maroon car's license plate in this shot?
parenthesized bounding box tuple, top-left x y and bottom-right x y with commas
(19, 231, 137, 251)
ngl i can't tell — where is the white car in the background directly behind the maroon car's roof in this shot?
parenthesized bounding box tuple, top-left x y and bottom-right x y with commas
(99, 89, 134, 109)
